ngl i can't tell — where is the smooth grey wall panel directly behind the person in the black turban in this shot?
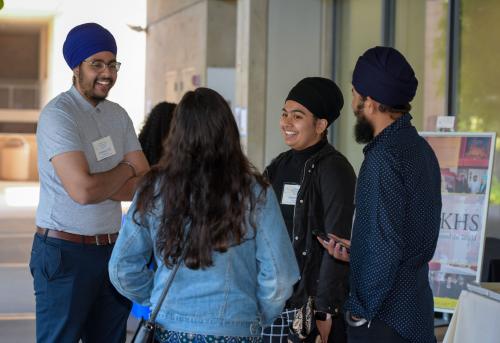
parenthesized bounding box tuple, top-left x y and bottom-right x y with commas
(265, 0, 329, 164)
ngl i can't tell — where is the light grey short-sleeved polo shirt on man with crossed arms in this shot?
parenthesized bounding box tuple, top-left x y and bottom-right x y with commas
(36, 87, 141, 235)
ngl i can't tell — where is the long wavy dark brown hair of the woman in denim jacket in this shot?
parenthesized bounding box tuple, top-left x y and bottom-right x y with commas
(134, 88, 267, 269)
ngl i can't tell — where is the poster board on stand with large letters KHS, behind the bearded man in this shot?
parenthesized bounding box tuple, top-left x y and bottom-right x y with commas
(420, 132, 496, 313)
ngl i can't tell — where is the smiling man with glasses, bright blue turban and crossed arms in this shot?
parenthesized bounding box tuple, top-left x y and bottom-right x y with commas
(30, 23, 149, 343)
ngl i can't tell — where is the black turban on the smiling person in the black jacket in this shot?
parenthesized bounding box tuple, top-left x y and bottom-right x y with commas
(286, 77, 344, 125)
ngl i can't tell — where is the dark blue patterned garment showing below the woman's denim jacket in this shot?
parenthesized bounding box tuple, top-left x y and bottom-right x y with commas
(155, 327, 262, 343)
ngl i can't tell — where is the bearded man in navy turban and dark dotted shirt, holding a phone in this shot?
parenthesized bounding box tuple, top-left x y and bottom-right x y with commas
(323, 47, 441, 343)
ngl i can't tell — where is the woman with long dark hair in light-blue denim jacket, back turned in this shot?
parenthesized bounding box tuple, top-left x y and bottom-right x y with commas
(109, 88, 298, 343)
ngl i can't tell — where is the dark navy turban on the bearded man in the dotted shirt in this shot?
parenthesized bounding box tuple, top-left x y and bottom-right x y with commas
(352, 46, 418, 108)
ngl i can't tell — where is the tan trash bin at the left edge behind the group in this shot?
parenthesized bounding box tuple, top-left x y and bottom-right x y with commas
(0, 136, 30, 181)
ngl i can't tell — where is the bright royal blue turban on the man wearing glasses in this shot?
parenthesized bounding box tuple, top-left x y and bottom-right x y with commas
(63, 23, 117, 69)
